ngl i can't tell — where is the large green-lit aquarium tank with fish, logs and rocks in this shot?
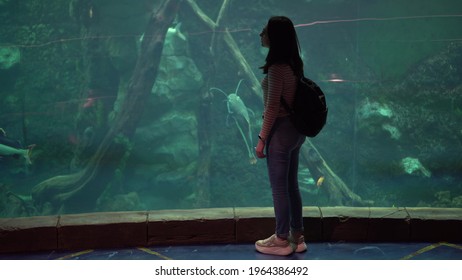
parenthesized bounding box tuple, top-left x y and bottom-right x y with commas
(0, 0, 462, 217)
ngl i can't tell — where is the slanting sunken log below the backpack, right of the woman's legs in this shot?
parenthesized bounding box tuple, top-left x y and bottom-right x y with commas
(300, 139, 374, 206)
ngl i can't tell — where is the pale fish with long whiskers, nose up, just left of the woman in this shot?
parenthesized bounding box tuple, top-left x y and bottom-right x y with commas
(210, 80, 257, 164)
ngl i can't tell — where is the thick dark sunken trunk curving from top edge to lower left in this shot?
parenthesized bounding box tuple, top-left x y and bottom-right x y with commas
(32, 0, 180, 213)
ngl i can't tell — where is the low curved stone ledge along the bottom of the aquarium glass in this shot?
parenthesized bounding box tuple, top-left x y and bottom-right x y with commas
(0, 207, 462, 253)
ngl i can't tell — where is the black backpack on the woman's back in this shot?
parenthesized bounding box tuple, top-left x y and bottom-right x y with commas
(281, 76, 328, 137)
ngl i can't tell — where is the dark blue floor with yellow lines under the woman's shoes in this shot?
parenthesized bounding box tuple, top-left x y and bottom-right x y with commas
(0, 242, 462, 260)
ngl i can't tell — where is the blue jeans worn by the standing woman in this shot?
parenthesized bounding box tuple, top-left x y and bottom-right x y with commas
(266, 117, 306, 239)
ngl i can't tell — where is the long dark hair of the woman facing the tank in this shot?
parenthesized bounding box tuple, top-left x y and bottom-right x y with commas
(260, 16, 303, 76)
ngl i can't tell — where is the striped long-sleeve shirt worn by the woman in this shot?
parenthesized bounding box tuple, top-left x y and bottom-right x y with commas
(259, 64, 297, 140)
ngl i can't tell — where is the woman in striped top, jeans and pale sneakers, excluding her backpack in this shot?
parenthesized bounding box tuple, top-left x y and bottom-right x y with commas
(255, 16, 307, 255)
